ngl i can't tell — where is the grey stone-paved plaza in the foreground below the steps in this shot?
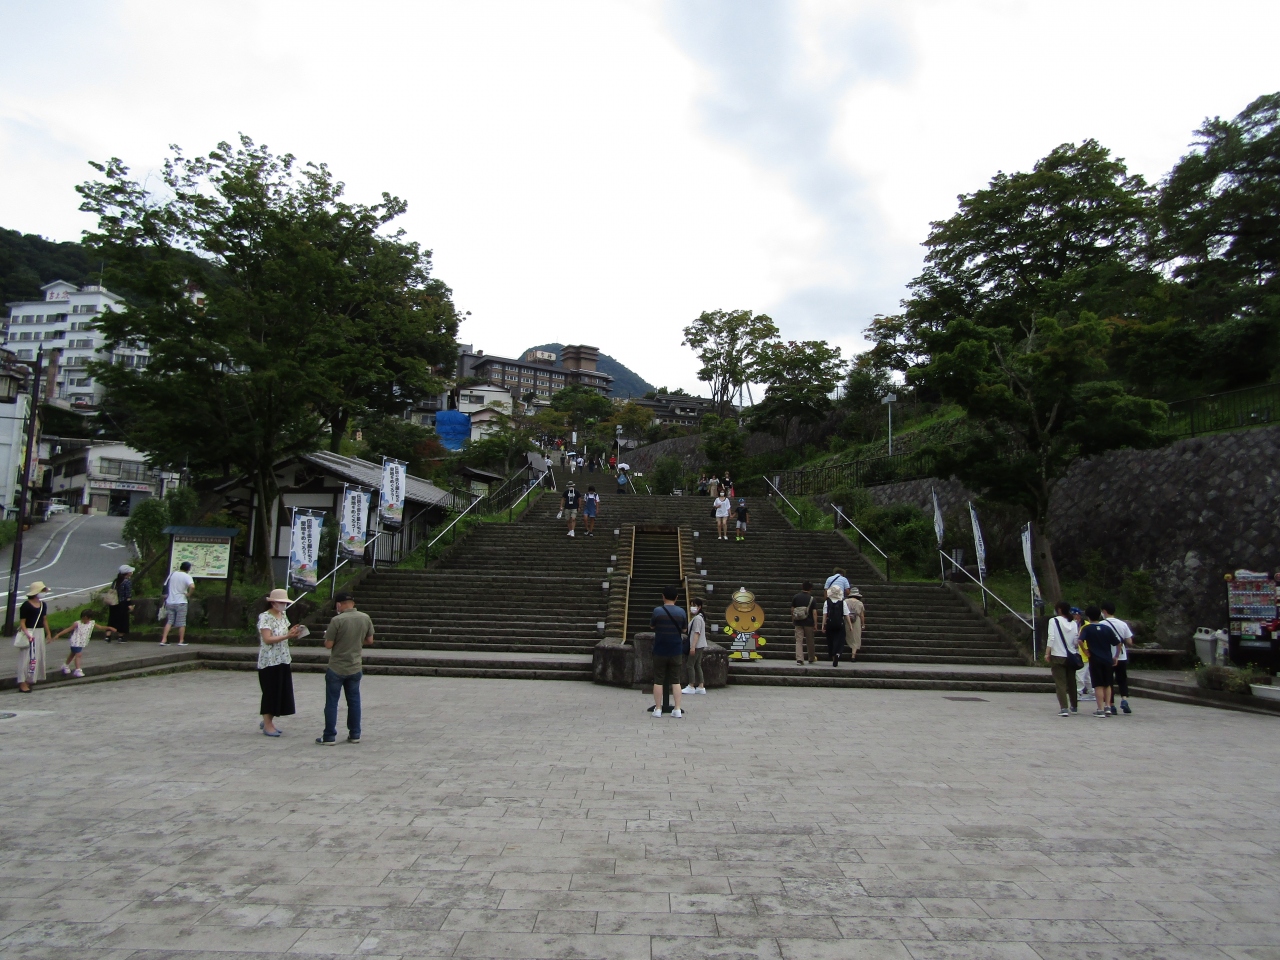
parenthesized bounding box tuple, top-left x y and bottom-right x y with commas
(0, 671, 1280, 960)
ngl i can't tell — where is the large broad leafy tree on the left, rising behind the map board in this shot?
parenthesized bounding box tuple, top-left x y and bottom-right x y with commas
(77, 137, 454, 579)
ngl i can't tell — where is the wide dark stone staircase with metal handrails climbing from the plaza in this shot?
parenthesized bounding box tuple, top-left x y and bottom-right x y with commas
(264, 468, 1047, 689)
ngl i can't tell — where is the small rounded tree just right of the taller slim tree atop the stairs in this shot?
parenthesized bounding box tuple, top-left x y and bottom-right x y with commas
(750, 340, 845, 444)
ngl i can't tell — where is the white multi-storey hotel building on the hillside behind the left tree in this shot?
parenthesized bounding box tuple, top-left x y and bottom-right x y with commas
(3, 280, 151, 408)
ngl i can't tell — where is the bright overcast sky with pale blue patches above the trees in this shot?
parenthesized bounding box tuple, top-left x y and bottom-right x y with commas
(0, 0, 1280, 393)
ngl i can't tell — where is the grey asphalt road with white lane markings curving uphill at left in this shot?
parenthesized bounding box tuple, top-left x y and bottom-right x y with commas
(0, 513, 133, 609)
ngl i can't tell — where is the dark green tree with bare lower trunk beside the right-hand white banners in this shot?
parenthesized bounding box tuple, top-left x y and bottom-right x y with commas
(909, 314, 1167, 600)
